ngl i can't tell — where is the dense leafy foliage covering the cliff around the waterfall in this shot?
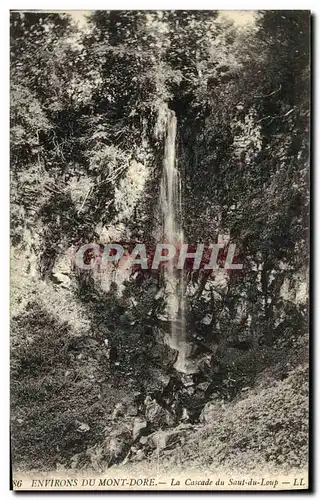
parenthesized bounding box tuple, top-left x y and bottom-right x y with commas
(11, 11, 310, 467)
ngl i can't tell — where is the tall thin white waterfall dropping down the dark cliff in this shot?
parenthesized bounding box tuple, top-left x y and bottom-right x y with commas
(160, 108, 186, 372)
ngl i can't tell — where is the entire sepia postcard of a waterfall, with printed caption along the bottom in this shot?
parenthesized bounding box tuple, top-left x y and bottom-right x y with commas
(10, 10, 311, 492)
